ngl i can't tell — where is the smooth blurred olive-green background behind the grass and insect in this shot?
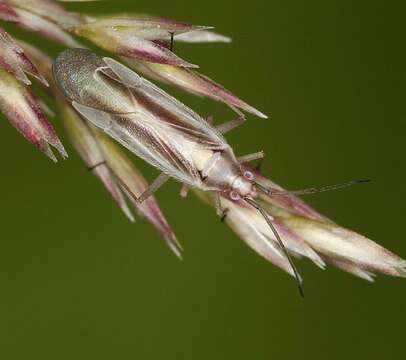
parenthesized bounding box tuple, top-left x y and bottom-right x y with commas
(0, 0, 406, 360)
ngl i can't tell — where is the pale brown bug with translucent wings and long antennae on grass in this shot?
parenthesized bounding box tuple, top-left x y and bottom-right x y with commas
(53, 49, 366, 294)
